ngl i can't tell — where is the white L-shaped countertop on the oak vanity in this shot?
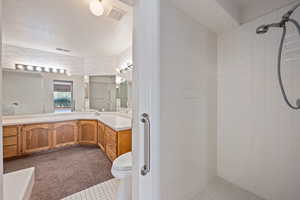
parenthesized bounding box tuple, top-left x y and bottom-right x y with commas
(2, 112, 132, 131)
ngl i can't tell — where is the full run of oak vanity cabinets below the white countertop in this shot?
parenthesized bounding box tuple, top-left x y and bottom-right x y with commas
(3, 120, 131, 161)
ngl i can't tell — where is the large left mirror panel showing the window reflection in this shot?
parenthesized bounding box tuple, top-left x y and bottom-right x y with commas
(2, 69, 85, 116)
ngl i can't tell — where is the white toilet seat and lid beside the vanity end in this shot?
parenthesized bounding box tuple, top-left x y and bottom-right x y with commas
(112, 152, 132, 172)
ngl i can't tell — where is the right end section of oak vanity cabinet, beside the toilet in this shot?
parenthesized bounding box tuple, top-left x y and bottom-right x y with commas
(105, 126, 131, 161)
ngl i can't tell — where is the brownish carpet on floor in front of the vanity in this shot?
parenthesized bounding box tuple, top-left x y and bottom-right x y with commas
(4, 146, 112, 200)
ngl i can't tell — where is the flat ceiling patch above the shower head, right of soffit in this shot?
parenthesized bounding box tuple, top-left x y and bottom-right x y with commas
(230, 0, 299, 23)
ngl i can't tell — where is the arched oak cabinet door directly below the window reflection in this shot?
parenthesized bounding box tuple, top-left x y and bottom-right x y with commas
(53, 121, 78, 147)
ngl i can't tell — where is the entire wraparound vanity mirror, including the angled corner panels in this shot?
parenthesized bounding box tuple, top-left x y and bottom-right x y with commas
(2, 69, 132, 116)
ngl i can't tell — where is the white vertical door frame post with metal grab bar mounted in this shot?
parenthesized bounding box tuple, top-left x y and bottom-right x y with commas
(132, 0, 160, 200)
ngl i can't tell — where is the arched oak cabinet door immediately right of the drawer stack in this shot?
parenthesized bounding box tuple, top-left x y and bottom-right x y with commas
(22, 124, 52, 153)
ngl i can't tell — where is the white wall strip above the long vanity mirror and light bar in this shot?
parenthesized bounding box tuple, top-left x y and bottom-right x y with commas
(2, 44, 118, 75)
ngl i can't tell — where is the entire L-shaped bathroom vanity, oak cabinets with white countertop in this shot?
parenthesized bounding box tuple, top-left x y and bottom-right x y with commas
(3, 113, 131, 161)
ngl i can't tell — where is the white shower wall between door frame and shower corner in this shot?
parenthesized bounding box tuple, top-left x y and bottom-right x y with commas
(160, 1, 217, 200)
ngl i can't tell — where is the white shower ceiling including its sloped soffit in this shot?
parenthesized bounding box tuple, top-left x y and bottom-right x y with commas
(172, 0, 299, 33)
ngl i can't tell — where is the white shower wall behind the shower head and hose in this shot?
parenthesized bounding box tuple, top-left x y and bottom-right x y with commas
(218, 3, 300, 200)
